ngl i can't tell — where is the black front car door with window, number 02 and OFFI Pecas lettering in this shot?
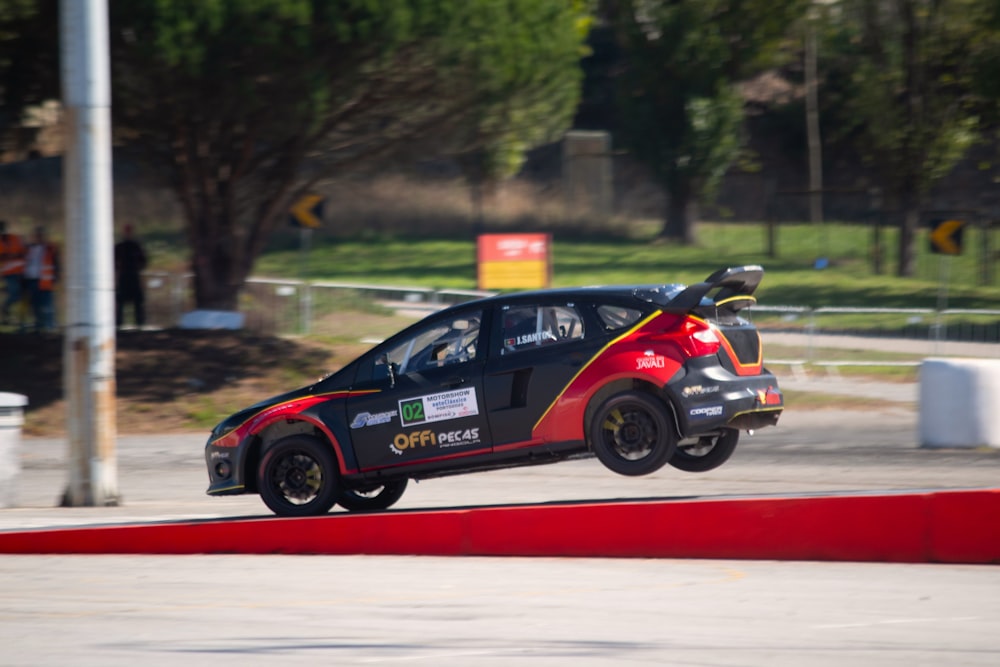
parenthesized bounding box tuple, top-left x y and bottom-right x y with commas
(347, 308, 491, 470)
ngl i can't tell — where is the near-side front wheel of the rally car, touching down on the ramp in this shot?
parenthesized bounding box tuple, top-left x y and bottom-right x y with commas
(257, 435, 339, 517)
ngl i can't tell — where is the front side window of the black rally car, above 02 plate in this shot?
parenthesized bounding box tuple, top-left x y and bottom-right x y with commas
(387, 311, 482, 375)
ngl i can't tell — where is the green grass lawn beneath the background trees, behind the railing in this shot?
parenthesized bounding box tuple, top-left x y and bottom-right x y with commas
(255, 223, 1000, 309)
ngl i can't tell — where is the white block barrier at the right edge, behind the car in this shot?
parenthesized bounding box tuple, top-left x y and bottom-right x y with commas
(919, 359, 1000, 448)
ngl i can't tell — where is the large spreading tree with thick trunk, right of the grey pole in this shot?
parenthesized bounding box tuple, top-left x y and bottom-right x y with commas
(111, 0, 592, 309)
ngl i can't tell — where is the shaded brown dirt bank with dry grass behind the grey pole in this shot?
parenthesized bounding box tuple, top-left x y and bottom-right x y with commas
(0, 329, 364, 436)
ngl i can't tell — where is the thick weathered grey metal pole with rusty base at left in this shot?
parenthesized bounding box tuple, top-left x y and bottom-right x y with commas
(59, 0, 119, 506)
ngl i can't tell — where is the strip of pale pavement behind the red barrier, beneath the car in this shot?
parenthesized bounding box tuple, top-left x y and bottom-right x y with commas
(0, 403, 1000, 529)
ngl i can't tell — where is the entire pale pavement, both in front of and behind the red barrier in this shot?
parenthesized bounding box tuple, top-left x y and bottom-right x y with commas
(0, 380, 1000, 667)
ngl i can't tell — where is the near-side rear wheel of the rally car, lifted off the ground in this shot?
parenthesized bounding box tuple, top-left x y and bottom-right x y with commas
(590, 391, 677, 476)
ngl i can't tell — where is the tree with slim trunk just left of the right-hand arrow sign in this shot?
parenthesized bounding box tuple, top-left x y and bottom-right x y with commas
(835, 0, 988, 276)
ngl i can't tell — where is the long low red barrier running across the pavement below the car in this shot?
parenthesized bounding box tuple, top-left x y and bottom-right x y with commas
(0, 489, 1000, 563)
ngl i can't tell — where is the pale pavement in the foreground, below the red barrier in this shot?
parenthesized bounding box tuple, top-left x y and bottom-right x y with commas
(0, 556, 1000, 667)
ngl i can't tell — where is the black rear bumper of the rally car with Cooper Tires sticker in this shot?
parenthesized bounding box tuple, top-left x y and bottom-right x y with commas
(664, 356, 785, 438)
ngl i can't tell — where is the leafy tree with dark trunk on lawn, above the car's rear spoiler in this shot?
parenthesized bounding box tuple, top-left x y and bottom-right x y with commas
(606, 0, 807, 243)
